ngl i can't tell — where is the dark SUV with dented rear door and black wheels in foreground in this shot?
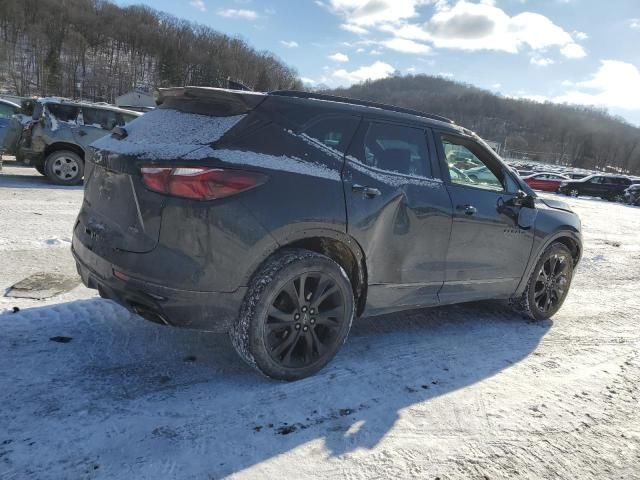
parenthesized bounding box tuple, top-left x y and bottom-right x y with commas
(72, 87, 582, 380)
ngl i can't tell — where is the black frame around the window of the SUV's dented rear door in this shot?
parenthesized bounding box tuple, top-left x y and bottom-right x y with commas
(345, 116, 440, 182)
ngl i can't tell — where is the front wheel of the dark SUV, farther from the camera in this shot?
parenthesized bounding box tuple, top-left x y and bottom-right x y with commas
(518, 243, 573, 320)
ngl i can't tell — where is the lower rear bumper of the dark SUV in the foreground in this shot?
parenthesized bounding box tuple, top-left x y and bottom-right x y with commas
(71, 237, 246, 333)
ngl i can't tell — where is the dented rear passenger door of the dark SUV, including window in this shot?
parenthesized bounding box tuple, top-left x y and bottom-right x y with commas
(343, 119, 451, 313)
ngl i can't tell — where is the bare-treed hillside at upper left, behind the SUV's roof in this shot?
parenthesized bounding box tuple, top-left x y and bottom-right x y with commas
(0, 0, 301, 102)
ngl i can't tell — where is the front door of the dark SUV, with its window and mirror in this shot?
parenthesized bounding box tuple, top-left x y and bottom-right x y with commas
(436, 133, 535, 303)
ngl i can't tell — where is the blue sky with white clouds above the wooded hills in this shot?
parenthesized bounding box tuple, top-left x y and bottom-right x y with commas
(117, 0, 640, 125)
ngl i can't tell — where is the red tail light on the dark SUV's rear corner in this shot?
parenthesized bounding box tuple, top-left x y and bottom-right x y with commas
(140, 167, 267, 200)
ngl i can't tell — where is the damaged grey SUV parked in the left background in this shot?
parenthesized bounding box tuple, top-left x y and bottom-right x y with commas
(5, 98, 141, 185)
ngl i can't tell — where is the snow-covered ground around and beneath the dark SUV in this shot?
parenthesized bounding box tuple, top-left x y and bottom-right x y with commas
(0, 163, 640, 480)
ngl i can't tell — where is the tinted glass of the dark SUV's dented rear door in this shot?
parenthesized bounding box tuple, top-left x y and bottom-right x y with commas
(353, 123, 431, 177)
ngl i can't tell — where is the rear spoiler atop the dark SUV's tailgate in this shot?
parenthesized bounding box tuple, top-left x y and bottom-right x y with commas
(157, 87, 267, 116)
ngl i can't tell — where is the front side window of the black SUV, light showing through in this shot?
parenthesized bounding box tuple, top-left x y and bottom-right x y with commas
(441, 135, 504, 191)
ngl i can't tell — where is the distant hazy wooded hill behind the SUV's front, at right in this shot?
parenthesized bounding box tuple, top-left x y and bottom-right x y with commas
(327, 75, 640, 174)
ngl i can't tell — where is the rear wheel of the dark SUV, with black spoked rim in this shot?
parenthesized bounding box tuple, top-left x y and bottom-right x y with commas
(230, 249, 355, 380)
